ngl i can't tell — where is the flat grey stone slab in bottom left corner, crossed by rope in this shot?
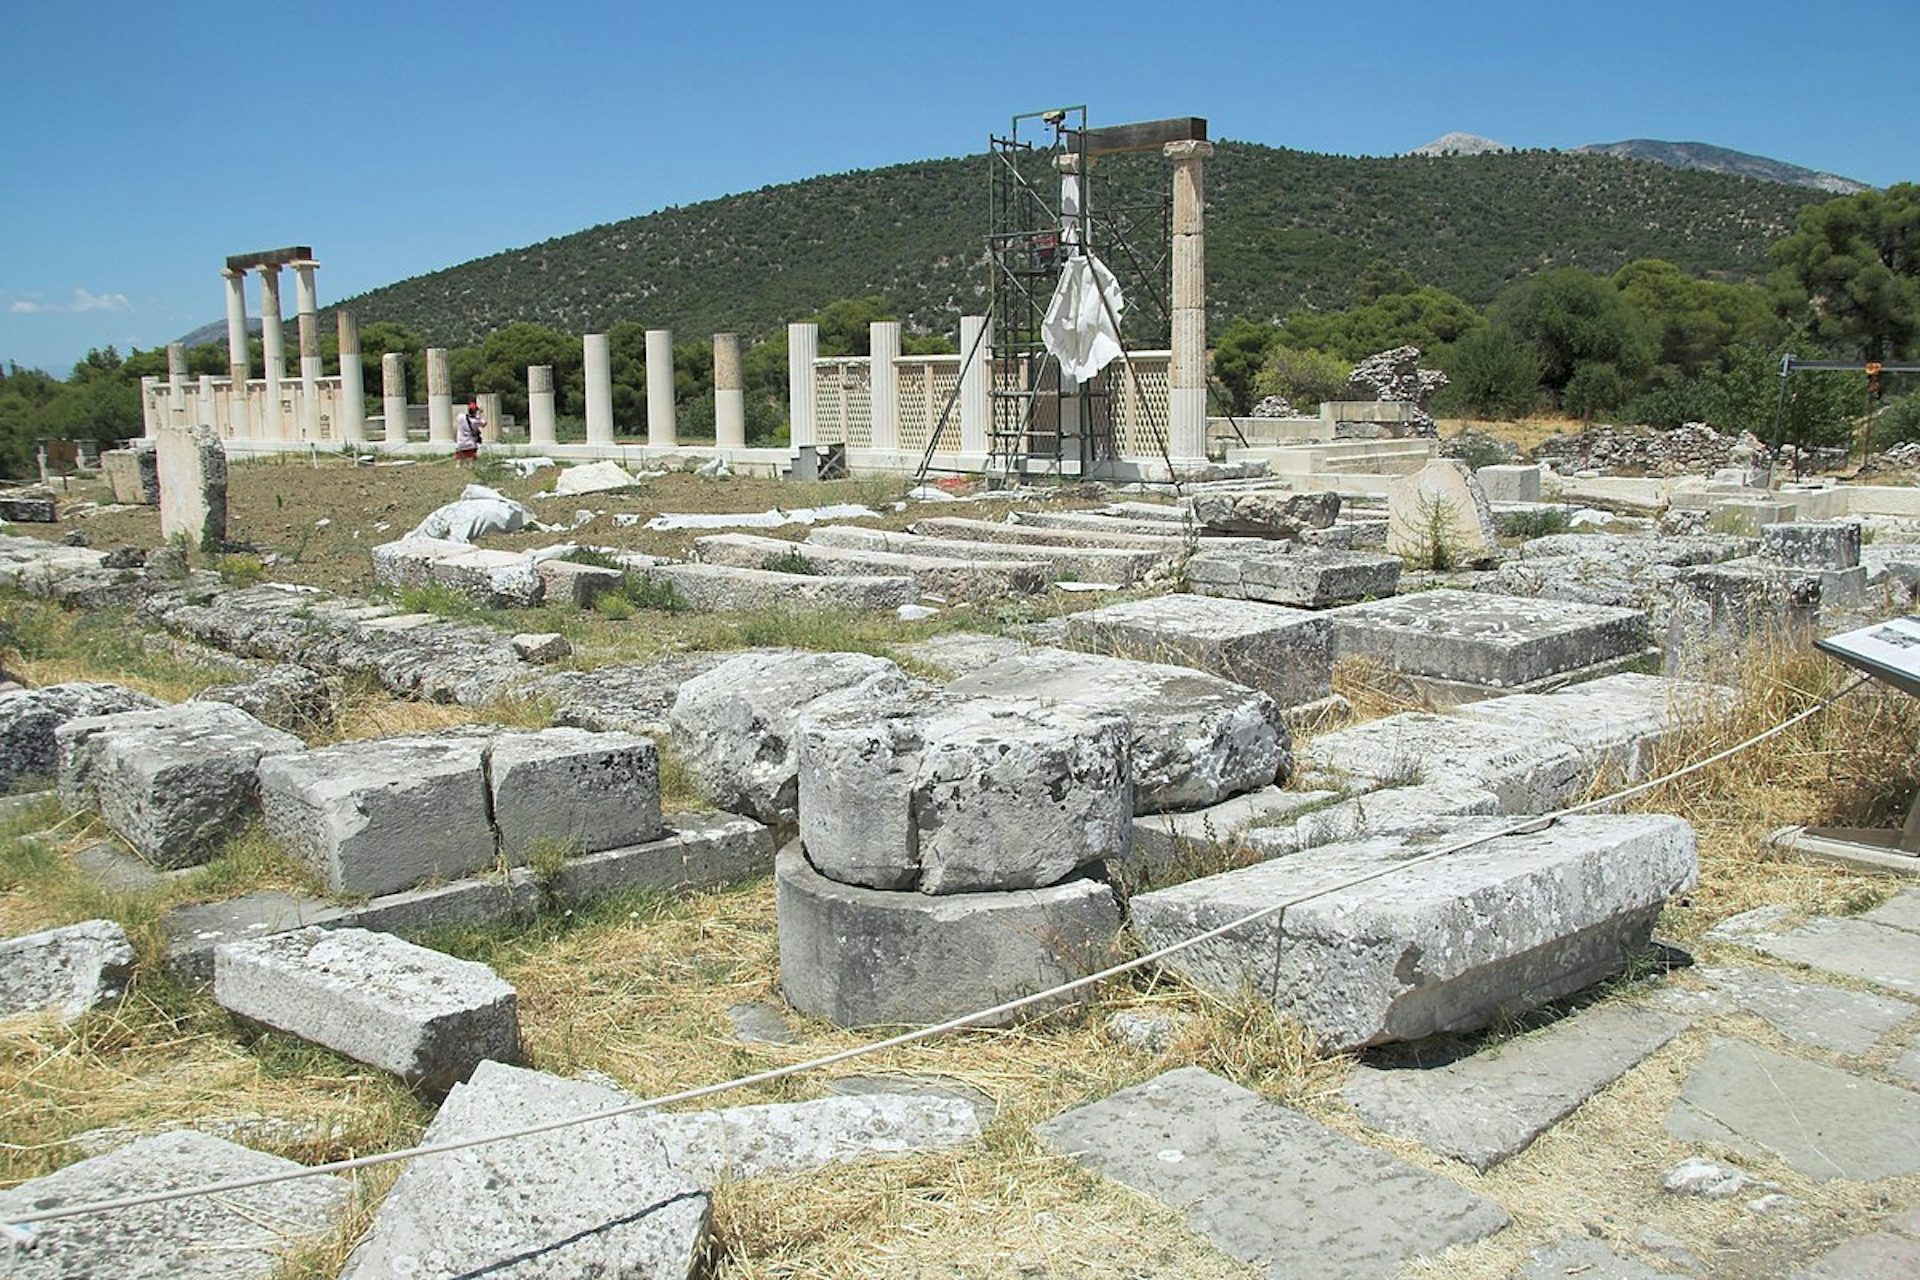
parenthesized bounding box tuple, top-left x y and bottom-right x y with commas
(0, 1130, 351, 1280)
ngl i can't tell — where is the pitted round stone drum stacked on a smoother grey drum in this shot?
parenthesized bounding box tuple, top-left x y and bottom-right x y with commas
(799, 699, 1133, 894)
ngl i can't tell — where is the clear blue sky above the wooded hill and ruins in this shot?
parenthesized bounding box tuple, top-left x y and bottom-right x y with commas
(0, 0, 1920, 372)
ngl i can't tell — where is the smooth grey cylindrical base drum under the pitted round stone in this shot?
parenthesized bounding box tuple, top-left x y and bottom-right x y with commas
(774, 842, 1119, 1027)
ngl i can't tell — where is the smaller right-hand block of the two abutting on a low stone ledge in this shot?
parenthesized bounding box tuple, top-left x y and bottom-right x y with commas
(488, 729, 662, 865)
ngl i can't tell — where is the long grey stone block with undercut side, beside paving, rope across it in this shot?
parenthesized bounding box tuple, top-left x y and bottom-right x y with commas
(1133, 816, 1699, 1048)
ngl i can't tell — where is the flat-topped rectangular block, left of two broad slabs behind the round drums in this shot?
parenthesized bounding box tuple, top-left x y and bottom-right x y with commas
(1066, 593, 1332, 708)
